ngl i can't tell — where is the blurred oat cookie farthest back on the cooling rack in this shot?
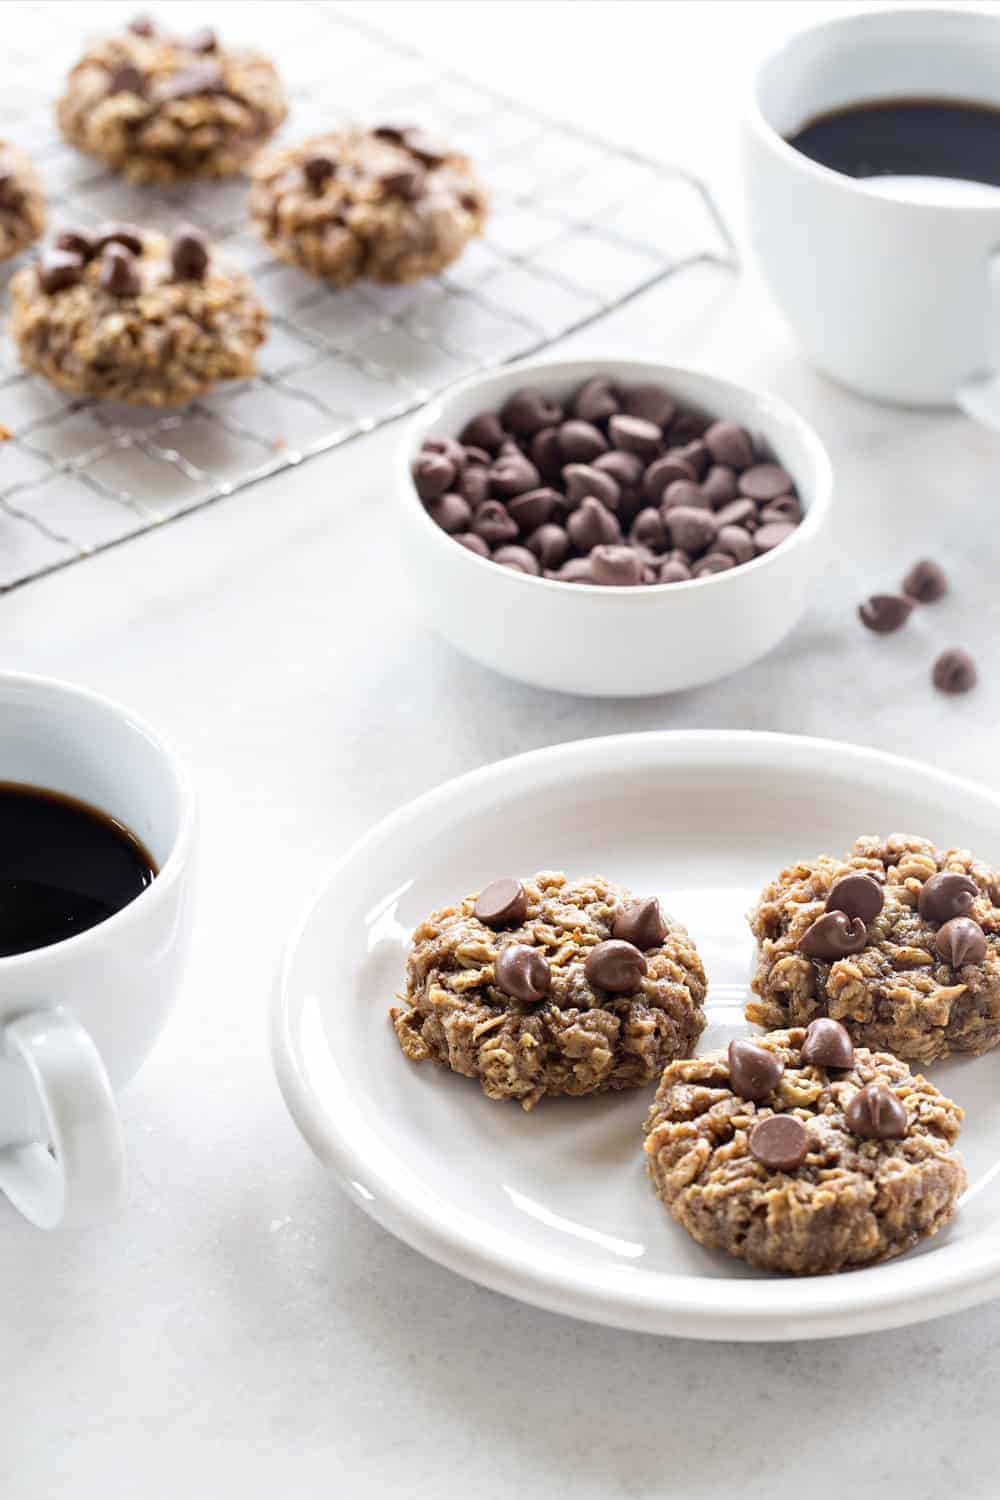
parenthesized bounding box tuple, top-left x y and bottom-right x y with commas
(55, 17, 288, 183)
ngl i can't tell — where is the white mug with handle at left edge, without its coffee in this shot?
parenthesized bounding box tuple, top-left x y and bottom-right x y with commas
(0, 672, 195, 1229)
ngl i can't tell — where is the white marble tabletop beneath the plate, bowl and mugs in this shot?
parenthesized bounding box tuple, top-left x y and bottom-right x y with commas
(0, 3, 1000, 1500)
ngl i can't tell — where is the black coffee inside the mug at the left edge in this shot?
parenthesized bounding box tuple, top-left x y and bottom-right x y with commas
(0, 782, 156, 959)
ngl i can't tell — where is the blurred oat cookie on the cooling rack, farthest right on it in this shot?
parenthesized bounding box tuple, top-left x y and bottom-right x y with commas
(250, 125, 487, 287)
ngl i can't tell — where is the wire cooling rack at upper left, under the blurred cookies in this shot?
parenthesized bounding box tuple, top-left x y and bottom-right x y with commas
(0, 0, 735, 590)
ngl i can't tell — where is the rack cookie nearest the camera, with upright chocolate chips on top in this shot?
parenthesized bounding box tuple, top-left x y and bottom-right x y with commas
(10, 225, 267, 407)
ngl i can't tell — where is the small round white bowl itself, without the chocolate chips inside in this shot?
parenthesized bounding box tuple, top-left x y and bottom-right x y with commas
(396, 360, 832, 698)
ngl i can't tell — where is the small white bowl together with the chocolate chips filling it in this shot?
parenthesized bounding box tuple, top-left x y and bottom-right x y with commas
(397, 360, 832, 698)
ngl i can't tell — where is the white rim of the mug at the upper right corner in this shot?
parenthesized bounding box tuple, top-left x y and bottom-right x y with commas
(744, 5, 1000, 219)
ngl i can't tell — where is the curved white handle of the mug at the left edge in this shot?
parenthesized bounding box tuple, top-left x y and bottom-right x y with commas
(0, 1010, 124, 1229)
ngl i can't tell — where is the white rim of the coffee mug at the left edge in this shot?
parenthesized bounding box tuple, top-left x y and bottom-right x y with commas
(0, 671, 198, 978)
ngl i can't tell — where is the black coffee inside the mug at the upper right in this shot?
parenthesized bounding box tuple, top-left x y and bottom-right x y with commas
(789, 99, 1000, 188)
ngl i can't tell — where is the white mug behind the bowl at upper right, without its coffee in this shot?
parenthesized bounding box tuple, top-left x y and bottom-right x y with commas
(745, 9, 1000, 407)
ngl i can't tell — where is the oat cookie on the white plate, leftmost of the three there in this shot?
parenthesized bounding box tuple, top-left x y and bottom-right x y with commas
(391, 872, 705, 1109)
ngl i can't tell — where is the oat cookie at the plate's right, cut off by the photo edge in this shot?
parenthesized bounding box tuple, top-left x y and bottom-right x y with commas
(747, 834, 1000, 1062)
